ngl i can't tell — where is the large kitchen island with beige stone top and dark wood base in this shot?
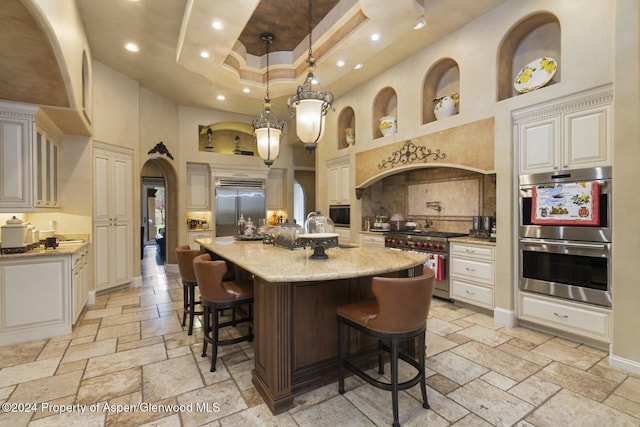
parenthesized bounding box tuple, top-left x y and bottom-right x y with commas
(196, 238, 427, 414)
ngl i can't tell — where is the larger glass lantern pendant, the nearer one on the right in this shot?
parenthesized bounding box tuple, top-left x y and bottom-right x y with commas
(288, 0, 333, 152)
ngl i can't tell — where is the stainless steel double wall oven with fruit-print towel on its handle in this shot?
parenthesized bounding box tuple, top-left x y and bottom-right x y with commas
(519, 167, 613, 307)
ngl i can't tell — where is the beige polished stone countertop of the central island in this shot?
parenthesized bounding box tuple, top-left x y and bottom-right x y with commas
(196, 237, 428, 283)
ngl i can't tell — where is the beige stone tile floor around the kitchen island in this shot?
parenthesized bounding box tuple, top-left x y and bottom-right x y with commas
(0, 247, 640, 427)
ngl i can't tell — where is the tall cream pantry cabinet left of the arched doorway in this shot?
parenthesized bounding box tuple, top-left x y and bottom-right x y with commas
(93, 143, 134, 291)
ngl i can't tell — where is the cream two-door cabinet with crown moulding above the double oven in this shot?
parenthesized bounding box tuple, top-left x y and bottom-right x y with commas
(513, 88, 612, 174)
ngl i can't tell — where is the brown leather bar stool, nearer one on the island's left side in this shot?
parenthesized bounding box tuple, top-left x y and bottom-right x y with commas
(193, 254, 253, 372)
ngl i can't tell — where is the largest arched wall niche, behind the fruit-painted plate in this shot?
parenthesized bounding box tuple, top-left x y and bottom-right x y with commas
(497, 12, 562, 101)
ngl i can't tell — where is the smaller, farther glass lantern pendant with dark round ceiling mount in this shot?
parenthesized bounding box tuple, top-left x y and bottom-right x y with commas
(251, 33, 284, 167)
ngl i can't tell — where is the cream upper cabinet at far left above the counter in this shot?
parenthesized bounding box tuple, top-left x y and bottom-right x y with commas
(0, 103, 62, 212)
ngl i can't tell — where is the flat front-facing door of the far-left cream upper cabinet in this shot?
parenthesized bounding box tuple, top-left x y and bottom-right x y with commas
(0, 117, 32, 211)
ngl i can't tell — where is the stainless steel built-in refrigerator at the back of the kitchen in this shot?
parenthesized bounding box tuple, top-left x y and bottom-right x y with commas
(215, 180, 266, 236)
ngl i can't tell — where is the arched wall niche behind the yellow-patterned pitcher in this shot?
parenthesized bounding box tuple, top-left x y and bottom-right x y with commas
(422, 58, 460, 124)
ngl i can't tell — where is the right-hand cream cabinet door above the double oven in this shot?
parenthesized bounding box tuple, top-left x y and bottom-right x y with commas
(564, 105, 611, 167)
